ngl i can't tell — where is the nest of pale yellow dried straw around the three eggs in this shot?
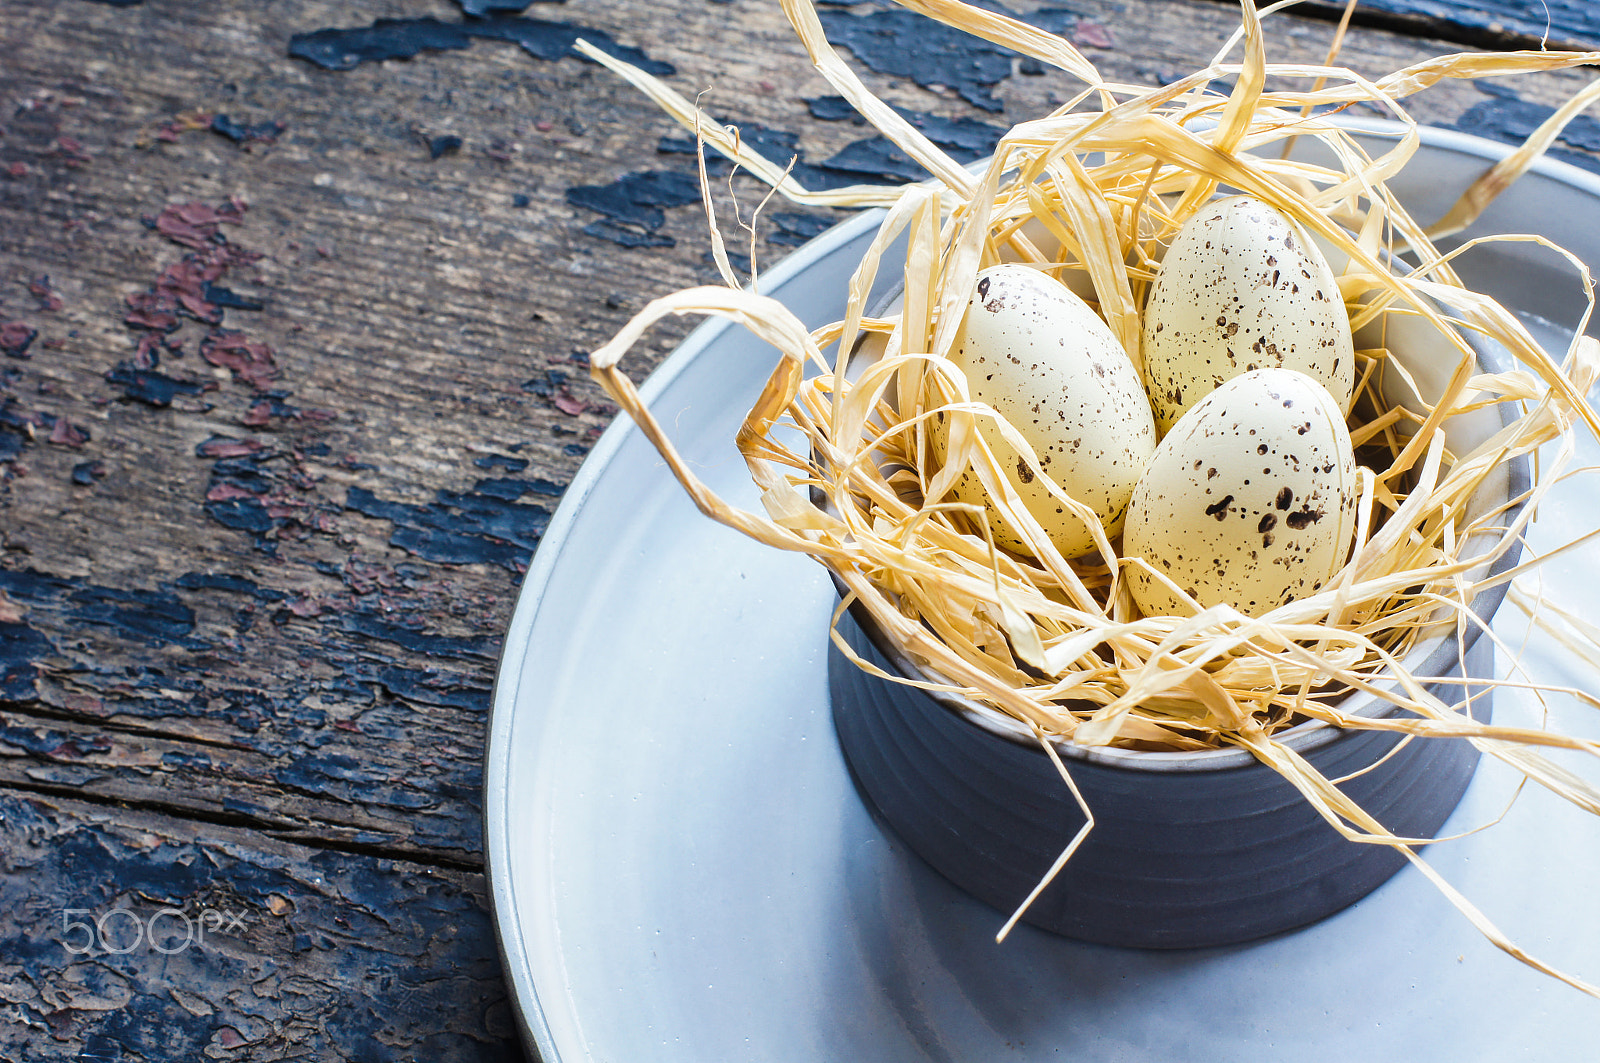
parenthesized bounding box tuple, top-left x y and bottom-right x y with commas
(581, 0, 1600, 996)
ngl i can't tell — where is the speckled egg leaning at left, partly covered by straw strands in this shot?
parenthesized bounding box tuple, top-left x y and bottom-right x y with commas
(933, 264, 1155, 557)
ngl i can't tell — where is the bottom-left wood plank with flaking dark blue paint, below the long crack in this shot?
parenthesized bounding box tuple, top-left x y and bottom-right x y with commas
(0, 796, 522, 1063)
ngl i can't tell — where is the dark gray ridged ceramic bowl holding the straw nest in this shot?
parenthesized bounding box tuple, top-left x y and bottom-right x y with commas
(829, 280, 1530, 948)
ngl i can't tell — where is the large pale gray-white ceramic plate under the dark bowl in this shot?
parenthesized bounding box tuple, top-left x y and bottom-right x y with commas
(485, 120, 1600, 1063)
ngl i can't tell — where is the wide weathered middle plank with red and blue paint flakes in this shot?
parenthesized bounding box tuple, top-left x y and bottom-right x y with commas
(0, 0, 1600, 863)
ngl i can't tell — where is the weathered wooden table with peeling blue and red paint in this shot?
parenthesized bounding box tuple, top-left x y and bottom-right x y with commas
(0, 0, 1600, 1061)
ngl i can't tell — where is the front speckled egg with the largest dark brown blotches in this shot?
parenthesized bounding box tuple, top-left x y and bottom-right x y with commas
(1123, 368, 1357, 616)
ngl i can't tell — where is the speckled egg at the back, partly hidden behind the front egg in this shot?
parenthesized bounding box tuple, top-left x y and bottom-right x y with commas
(1142, 195, 1355, 434)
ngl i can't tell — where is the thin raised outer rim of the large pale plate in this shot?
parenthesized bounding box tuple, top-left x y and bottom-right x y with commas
(480, 115, 1600, 1063)
